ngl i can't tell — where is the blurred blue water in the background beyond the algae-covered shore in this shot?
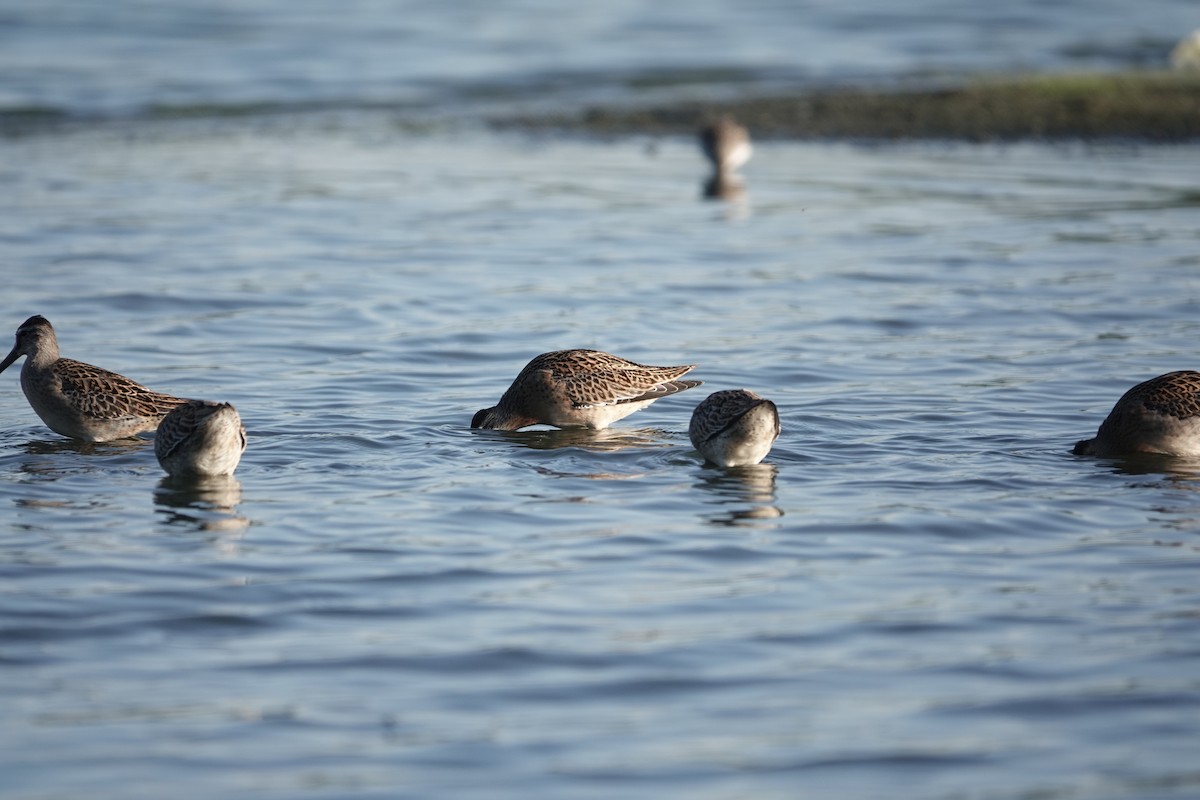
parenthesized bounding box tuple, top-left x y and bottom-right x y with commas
(0, 0, 1200, 115)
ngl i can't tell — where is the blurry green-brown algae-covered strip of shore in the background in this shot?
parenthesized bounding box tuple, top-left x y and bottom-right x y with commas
(496, 71, 1200, 143)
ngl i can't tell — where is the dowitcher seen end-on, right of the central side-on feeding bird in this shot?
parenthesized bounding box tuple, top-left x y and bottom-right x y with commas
(688, 389, 780, 467)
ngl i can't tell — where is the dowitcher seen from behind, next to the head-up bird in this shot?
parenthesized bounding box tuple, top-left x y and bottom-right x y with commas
(154, 401, 246, 477)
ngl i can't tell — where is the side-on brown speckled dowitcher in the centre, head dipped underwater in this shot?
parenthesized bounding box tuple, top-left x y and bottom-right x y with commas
(470, 350, 703, 431)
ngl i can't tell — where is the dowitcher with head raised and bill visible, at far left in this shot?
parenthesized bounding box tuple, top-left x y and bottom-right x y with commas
(0, 315, 185, 441)
